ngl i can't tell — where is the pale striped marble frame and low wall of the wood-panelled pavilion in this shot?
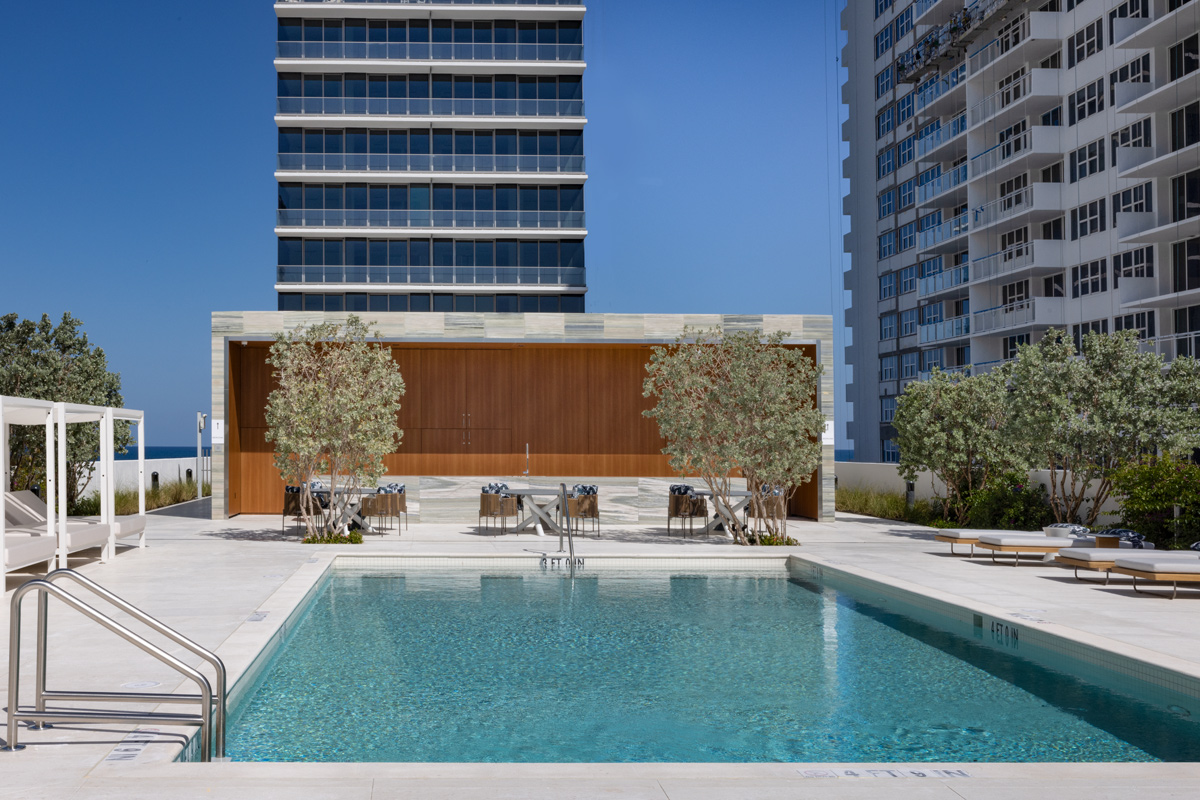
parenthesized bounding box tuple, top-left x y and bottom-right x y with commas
(212, 311, 834, 522)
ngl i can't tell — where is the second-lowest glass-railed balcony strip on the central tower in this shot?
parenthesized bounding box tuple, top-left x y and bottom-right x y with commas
(276, 209, 584, 230)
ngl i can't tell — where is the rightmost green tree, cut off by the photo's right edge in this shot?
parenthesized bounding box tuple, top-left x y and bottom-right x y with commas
(1007, 330, 1200, 525)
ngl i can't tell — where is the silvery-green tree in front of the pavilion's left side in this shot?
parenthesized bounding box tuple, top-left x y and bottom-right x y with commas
(266, 315, 404, 537)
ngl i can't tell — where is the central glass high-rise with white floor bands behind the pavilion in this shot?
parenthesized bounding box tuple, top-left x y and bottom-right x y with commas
(275, 0, 587, 312)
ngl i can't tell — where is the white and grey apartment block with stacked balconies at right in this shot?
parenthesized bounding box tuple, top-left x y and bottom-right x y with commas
(841, 0, 1200, 462)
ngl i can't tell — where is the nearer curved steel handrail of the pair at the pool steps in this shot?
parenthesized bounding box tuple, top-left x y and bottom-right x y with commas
(5, 578, 212, 762)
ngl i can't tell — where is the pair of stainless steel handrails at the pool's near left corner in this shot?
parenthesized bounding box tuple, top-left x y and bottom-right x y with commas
(4, 570, 226, 762)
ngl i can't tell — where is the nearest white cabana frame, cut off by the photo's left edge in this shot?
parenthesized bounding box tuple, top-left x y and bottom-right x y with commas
(0, 396, 60, 573)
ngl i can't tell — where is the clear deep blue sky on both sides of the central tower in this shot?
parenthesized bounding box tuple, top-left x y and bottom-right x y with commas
(0, 0, 848, 446)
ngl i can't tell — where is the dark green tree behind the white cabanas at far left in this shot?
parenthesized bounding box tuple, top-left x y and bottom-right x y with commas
(0, 313, 132, 509)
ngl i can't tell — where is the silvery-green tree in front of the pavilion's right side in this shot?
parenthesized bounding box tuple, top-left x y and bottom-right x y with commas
(643, 327, 824, 545)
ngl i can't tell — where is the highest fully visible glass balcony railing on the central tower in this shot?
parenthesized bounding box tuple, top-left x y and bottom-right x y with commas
(275, 42, 583, 61)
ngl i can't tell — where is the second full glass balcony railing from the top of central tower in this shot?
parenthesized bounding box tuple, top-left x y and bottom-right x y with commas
(276, 97, 583, 116)
